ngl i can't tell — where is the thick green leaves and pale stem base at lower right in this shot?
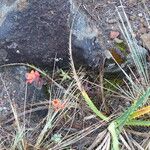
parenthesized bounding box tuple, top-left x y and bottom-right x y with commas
(108, 88, 150, 150)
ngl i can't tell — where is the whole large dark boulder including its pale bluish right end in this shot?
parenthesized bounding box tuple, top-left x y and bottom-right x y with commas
(0, 0, 103, 68)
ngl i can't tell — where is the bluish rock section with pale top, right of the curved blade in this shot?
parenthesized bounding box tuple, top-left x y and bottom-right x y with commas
(71, 2, 103, 68)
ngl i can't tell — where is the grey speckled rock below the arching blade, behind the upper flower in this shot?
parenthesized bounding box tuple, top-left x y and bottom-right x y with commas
(0, 66, 48, 121)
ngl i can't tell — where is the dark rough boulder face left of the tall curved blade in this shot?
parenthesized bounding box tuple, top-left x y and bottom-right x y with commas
(0, 0, 70, 66)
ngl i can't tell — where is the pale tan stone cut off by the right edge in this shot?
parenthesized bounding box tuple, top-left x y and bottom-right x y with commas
(141, 32, 150, 51)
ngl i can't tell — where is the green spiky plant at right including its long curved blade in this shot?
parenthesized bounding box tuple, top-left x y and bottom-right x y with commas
(69, 0, 150, 150)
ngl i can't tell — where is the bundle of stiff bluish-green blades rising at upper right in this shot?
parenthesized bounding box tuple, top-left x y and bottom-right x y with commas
(116, 0, 149, 84)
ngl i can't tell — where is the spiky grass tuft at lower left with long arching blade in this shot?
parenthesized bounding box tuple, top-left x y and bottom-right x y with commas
(0, 64, 74, 150)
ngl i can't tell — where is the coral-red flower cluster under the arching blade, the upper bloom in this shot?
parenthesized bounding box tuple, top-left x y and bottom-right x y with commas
(25, 70, 40, 84)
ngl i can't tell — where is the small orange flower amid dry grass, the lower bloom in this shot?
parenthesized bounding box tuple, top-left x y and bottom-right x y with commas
(52, 99, 65, 111)
